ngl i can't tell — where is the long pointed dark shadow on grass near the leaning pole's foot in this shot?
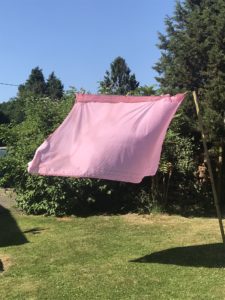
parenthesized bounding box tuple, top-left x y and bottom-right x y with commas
(130, 244, 225, 268)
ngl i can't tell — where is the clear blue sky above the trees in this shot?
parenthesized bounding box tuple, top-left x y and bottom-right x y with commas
(0, 0, 175, 102)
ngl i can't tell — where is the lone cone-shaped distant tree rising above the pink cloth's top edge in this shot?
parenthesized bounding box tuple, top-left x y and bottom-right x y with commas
(99, 56, 139, 95)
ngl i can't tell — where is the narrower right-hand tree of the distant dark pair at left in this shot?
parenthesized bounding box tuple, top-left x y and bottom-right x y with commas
(46, 72, 63, 100)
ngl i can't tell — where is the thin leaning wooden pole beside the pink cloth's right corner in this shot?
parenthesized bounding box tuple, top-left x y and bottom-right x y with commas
(193, 91, 225, 246)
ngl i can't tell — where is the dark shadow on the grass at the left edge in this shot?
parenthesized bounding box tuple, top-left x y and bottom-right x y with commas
(0, 205, 28, 247)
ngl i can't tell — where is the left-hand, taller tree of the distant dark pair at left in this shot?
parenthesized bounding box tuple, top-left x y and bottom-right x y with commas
(19, 67, 46, 97)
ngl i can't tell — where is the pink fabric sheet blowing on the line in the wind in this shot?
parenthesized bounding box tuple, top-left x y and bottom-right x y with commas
(28, 94, 184, 183)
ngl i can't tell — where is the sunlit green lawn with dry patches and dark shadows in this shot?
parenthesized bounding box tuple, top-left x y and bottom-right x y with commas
(0, 209, 225, 300)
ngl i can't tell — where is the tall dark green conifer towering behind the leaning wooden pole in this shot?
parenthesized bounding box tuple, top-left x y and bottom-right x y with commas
(154, 0, 225, 204)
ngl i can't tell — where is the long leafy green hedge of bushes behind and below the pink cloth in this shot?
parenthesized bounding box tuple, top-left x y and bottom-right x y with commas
(0, 94, 214, 215)
